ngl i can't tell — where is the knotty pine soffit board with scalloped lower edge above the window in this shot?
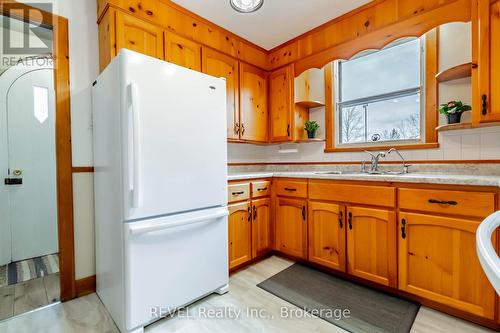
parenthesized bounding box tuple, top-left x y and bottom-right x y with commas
(269, 0, 471, 75)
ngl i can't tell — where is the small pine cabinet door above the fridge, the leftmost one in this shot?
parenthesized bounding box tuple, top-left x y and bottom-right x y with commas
(116, 12, 164, 60)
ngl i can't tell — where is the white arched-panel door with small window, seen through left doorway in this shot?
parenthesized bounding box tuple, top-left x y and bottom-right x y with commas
(2, 69, 58, 261)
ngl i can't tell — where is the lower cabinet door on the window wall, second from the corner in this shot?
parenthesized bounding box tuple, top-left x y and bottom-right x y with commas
(308, 201, 346, 271)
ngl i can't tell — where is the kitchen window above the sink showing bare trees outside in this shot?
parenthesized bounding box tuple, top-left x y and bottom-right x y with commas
(334, 38, 425, 146)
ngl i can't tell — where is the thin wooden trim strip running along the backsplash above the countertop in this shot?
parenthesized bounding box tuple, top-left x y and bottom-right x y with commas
(227, 160, 500, 166)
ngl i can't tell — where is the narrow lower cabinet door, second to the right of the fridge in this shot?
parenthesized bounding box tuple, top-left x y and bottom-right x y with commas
(252, 198, 271, 258)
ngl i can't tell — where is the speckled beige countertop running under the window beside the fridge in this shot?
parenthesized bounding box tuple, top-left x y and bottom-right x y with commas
(228, 171, 500, 187)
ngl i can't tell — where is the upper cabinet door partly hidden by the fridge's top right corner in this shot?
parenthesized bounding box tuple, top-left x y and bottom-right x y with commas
(201, 47, 240, 140)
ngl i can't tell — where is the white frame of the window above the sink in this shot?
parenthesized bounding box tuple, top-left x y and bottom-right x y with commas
(332, 36, 426, 148)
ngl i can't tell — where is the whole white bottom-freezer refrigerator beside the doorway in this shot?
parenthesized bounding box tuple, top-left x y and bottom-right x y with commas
(92, 50, 229, 332)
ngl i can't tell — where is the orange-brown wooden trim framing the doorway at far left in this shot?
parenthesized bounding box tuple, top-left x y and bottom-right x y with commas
(0, 0, 76, 301)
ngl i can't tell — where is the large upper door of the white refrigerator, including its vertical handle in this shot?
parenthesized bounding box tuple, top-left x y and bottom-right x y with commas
(120, 50, 227, 220)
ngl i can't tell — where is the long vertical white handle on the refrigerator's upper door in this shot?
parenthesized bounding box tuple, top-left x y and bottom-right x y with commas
(127, 82, 140, 208)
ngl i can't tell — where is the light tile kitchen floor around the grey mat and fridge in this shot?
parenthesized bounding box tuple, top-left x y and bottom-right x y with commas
(0, 257, 493, 333)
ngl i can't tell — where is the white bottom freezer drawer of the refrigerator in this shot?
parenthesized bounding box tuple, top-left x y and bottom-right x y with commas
(124, 207, 229, 330)
